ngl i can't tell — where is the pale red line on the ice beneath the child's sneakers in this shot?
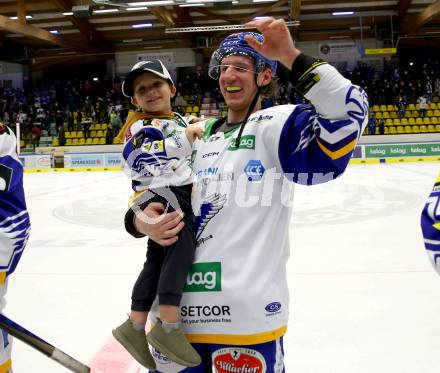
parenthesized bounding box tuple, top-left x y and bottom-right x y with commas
(89, 337, 142, 373)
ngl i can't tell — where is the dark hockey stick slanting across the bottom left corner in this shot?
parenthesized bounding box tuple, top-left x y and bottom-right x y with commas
(0, 314, 90, 373)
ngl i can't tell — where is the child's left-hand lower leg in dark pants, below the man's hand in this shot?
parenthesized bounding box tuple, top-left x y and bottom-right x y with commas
(130, 240, 164, 323)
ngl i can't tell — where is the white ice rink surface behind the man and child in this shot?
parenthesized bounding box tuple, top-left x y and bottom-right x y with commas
(5, 163, 440, 373)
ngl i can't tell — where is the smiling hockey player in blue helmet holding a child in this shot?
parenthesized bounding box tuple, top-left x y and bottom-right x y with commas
(123, 17, 368, 373)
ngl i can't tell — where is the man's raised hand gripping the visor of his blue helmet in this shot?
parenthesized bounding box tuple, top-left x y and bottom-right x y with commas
(245, 17, 301, 70)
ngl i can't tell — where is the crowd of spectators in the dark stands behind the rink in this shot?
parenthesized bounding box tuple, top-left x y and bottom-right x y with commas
(0, 58, 440, 147)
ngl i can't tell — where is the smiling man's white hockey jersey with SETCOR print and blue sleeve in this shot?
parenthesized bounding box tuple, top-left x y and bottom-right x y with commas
(150, 63, 368, 345)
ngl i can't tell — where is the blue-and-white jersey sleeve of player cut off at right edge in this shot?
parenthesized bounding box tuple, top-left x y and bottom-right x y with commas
(421, 174, 440, 274)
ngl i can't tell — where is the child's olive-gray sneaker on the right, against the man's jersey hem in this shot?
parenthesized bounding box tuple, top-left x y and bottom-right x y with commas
(147, 321, 202, 367)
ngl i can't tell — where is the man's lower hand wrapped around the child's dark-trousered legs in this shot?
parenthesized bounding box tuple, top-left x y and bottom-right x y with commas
(134, 202, 185, 246)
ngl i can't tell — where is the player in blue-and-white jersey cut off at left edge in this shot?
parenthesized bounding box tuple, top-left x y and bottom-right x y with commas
(0, 123, 30, 373)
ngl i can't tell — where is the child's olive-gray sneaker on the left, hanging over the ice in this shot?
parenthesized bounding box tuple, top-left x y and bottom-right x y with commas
(112, 319, 156, 370)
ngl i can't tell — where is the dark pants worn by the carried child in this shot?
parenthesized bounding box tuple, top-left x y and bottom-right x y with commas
(131, 185, 196, 311)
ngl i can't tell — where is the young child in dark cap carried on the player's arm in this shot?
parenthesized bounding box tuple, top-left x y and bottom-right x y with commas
(113, 60, 202, 370)
